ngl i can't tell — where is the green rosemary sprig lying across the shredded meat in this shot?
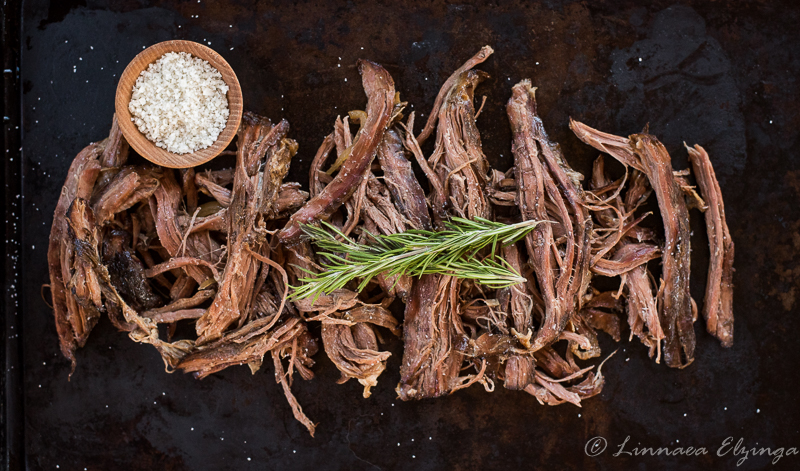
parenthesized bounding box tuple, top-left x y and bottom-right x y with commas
(291, 217, 542, 300)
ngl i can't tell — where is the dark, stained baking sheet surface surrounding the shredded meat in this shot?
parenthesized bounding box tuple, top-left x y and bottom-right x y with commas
(3, 0, 800, 470)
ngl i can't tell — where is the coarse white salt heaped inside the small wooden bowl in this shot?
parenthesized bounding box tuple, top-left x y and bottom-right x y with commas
(128, 52, 229, 154)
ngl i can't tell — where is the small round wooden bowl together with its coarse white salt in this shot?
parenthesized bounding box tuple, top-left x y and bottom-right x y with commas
(115, 41, 242, 168)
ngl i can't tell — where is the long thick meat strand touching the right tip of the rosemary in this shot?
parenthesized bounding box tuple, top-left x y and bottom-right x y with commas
(507, 84, 592, 358)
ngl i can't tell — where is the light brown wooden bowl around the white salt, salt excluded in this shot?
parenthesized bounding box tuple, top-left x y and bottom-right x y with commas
(115, 41, 242, 168)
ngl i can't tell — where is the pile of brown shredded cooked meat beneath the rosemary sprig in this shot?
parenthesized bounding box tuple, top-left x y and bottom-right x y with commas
(48, 46, 733, 435)
